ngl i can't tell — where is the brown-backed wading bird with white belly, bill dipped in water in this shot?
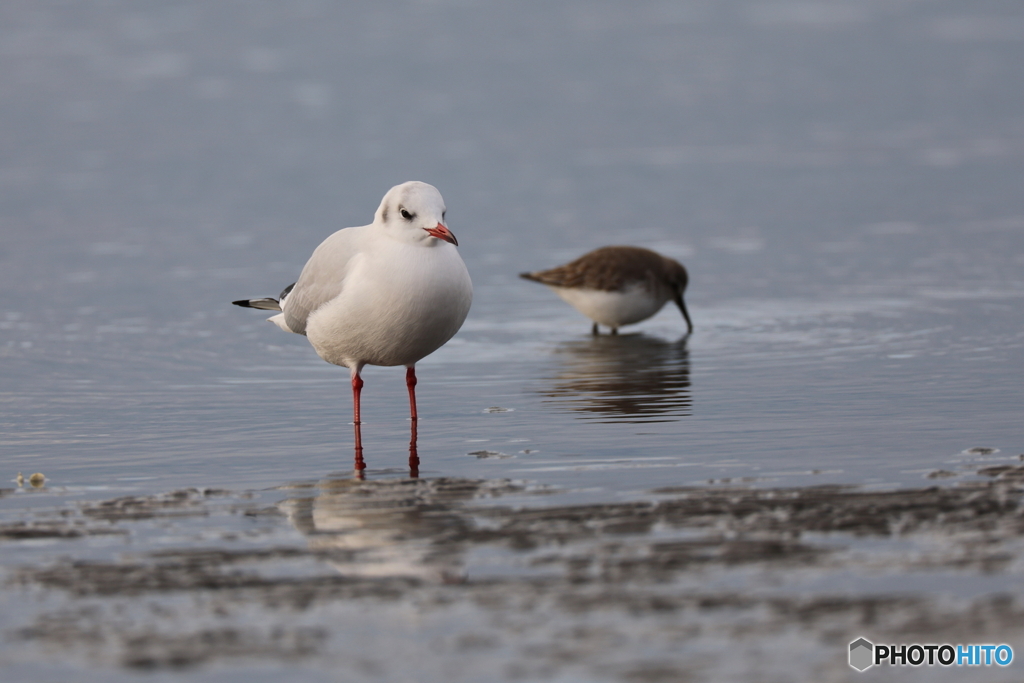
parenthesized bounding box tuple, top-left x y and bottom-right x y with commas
(519, 247, 693, 335)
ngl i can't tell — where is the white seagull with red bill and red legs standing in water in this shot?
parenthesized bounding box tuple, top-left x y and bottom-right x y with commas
(232, 181, 473, 461)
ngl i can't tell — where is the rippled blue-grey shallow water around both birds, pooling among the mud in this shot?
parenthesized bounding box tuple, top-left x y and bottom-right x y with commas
(0, 0, 1024, 680)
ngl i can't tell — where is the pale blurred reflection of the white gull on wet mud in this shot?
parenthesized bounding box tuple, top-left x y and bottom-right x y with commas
(279, 478, 490, 583)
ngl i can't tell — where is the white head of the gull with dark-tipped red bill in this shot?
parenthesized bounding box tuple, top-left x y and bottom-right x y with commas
(374, 180, 459, 247)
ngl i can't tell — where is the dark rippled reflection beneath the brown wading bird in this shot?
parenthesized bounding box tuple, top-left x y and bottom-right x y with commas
(540, 334, 692, 422)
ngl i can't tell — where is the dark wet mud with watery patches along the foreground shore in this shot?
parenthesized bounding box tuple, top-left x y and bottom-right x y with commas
(0, 462, 1024, 682)
